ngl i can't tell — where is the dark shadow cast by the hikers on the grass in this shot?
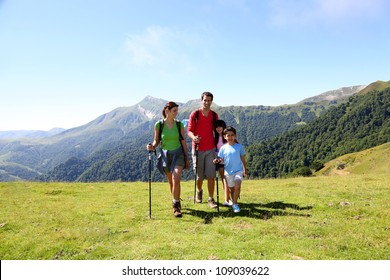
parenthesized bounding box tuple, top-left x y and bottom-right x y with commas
(183, 201, 312, 224)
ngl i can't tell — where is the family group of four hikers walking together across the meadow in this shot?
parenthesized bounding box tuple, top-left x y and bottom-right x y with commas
(146, 92, 246, 217)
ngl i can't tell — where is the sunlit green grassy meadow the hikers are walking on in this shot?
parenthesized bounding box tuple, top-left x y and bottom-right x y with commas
(0, 174, 390, 260)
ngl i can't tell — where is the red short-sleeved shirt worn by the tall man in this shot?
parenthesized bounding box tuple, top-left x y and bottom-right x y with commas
(188, 109, 218, 151)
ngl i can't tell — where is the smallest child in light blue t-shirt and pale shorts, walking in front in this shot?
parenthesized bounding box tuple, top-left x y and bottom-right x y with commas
(214, 126, 246, 213)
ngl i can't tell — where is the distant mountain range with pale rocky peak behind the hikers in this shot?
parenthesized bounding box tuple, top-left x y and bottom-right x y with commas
(0, 81, 389, 181)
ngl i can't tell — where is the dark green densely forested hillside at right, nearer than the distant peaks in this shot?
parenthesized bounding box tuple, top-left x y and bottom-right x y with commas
(247, 88, 390, 178)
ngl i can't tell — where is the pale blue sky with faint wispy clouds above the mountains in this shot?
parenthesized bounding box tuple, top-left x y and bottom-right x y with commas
(0, 0, 390, 130)
